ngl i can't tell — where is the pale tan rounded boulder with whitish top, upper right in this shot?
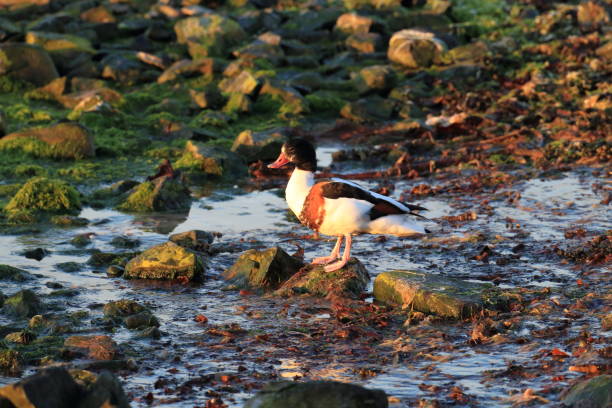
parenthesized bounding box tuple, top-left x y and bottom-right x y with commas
(387, 29, 445, 68)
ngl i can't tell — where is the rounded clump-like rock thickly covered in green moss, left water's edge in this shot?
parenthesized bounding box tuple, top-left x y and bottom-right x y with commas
(4, 177, 81, 220)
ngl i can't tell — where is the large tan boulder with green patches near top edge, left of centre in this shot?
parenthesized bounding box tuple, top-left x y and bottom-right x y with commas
(174, 13, 247, 59)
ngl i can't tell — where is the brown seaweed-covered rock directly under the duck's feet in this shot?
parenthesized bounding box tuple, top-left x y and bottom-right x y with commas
(275, 258, 370, 298)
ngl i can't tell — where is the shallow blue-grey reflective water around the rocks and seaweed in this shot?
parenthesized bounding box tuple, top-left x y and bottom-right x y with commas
(0, 159, 610, 407)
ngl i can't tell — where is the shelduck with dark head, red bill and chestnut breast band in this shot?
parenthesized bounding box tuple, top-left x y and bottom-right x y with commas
(268, 139, 429, 272)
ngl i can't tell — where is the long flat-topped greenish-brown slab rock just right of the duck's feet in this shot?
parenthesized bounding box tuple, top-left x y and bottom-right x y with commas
(374, 271, 506, 319)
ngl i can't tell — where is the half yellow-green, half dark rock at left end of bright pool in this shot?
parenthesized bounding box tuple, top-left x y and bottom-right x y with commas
(117, 176, 191, 212)
